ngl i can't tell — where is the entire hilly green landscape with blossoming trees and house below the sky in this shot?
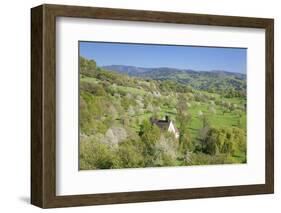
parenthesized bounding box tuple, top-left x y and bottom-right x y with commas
(79, 57, 247, 170)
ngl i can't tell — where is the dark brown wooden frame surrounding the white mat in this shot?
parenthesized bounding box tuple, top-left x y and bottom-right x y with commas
(31, 5, 274, 208)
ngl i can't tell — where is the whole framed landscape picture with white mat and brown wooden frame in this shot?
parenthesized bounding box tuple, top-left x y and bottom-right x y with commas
(31, 5, 274, 208)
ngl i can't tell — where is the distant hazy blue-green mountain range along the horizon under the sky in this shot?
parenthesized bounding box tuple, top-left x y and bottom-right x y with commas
(101, 65, 247, 92)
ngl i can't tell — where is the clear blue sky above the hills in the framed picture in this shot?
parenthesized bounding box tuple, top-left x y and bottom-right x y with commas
(79, 41, 247, 73)
